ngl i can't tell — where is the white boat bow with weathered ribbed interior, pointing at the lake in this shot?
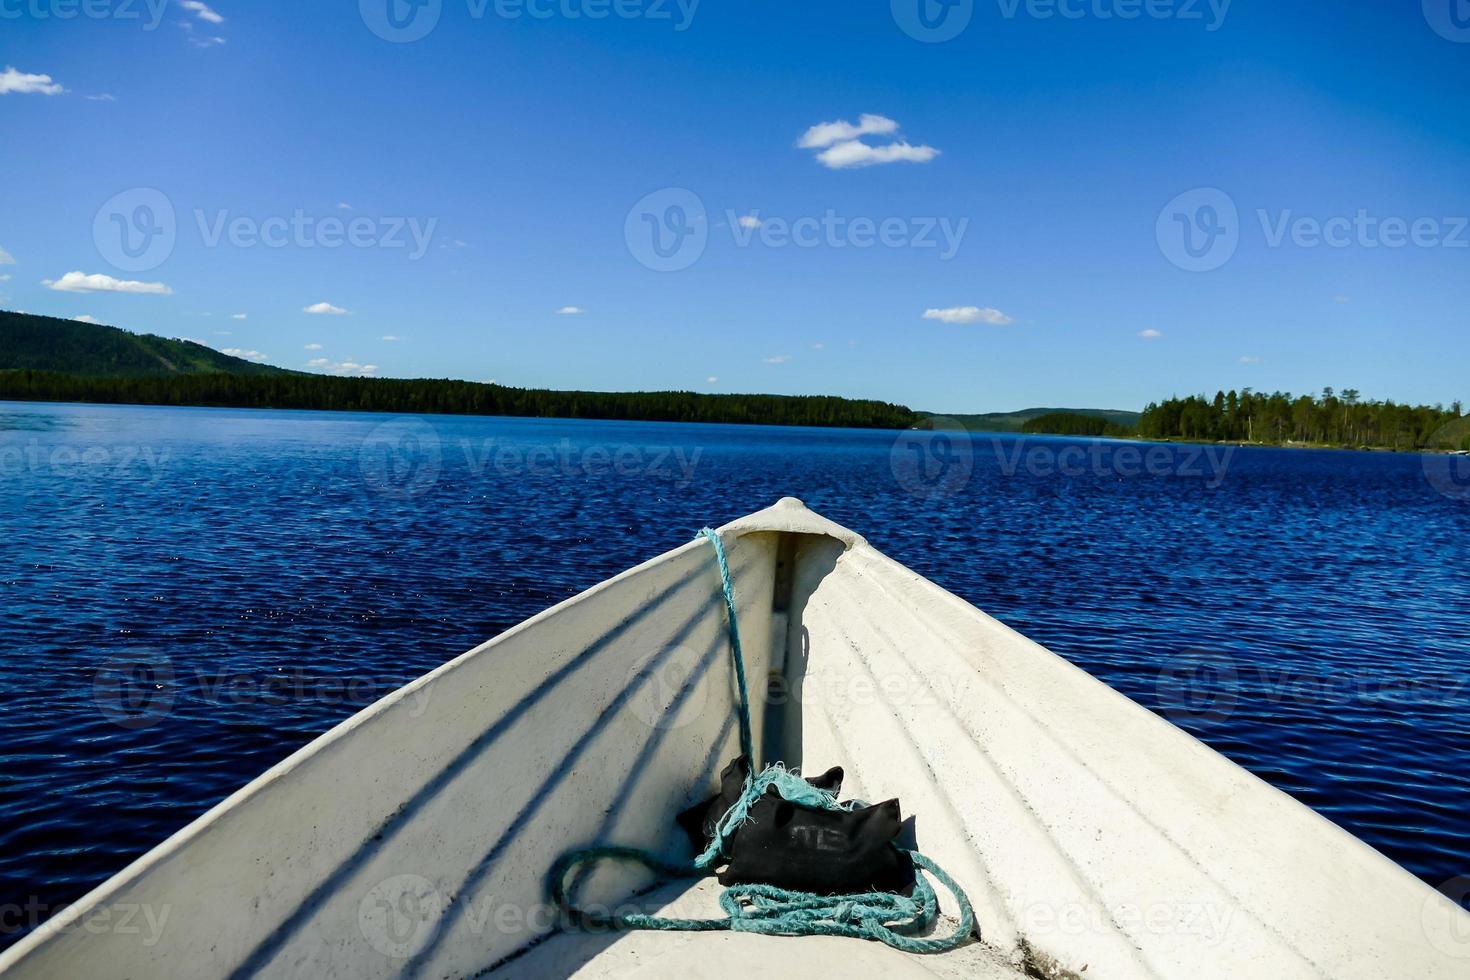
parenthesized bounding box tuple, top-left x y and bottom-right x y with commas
(0, 498, 1470, 980)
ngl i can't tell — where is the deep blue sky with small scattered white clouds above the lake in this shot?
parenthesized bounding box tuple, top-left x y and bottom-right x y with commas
(0, 0, 1470, 411)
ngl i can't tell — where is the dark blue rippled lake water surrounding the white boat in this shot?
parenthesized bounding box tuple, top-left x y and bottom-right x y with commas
(0, 403, 1470, 945)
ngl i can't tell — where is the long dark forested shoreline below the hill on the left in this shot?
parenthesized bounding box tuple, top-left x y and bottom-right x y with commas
(0, 370, 923, 429)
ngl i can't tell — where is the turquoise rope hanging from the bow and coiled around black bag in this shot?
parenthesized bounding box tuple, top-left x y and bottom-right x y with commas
(551, 527, 975, 954)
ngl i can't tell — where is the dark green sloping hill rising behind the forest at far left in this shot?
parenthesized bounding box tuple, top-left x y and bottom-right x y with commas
(0, 311, 294, 378)
